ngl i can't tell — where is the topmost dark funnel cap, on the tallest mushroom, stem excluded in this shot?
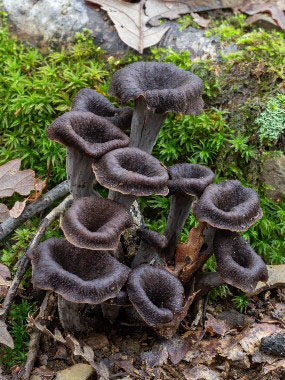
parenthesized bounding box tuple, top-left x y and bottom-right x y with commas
(109, 62, 204, 115)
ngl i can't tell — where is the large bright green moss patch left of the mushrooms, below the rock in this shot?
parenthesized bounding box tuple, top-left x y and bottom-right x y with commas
(0, 16, 109, 184)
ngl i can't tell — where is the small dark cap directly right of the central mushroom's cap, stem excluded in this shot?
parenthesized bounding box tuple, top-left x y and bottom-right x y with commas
(168, 164, 212, 196)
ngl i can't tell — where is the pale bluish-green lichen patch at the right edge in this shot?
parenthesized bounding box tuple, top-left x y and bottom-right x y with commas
(256, 94, 285, 142)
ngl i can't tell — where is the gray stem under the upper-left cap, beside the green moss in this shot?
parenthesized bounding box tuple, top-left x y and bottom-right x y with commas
(66, 147, 95, 199)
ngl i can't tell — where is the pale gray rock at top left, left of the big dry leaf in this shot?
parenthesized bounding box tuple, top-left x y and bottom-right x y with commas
(3, 0, 128, 54)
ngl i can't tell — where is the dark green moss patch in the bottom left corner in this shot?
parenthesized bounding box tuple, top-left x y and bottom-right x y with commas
(0, 300, 35, 367)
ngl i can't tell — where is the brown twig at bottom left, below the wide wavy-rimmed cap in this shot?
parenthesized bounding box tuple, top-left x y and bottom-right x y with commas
(18, 292, 56, 380)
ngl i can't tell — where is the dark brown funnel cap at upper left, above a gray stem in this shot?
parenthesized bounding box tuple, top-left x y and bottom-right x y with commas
(47, 111, 129, 158)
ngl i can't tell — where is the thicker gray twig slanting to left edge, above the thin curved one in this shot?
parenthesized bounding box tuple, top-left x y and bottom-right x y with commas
(0, 181, 69, 242)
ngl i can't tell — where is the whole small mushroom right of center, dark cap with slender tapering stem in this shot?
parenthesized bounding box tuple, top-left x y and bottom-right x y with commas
(164, 163, 214, 260)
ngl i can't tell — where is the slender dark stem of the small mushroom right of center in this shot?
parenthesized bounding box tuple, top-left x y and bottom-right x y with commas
(163, 194, 194, 261)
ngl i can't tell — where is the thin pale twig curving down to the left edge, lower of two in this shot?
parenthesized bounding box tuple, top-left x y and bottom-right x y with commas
(0, 195, 72, 321)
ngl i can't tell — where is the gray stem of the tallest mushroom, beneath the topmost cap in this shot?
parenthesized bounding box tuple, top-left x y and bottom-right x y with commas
(129, 96, 167, 154)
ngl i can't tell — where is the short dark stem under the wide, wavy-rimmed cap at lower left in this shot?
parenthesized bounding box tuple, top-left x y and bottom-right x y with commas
(57, 295, 86, 331)
